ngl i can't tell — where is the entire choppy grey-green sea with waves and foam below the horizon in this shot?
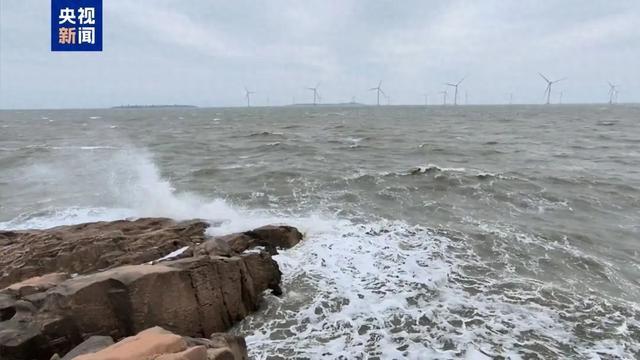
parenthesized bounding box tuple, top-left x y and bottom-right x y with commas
(0, 105, 640, 359)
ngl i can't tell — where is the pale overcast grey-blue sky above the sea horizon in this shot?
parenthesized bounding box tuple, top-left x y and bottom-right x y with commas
(0, 0, 640, 109)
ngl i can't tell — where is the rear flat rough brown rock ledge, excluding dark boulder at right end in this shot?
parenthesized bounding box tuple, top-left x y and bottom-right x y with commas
(0, 218, 209, 287)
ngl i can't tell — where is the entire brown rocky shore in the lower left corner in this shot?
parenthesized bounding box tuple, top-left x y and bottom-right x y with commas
(0, 218, 302, 360)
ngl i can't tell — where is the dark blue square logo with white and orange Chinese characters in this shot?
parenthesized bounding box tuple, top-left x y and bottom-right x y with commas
(51, 0, 102, 51)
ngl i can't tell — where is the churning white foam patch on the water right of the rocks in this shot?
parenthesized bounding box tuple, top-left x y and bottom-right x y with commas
(237, 219, 633, 359)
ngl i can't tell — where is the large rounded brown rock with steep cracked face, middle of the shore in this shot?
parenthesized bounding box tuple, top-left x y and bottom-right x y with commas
(0, 253, 280, 359)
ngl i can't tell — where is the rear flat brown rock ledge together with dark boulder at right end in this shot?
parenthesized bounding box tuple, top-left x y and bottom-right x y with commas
(0, 218, 302, 288)
